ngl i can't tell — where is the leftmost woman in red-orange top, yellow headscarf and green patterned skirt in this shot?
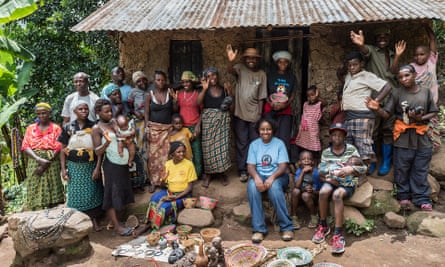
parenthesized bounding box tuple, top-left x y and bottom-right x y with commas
(21, 103, 65, 210)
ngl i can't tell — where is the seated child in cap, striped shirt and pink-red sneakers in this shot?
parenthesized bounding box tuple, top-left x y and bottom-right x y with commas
(312, 123, 367, 254)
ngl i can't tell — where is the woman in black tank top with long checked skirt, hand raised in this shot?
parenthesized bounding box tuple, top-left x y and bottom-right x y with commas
(198, 68, 232, 188)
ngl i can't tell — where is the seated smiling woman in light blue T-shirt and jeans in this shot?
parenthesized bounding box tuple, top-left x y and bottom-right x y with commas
(247, 118, 294, 243)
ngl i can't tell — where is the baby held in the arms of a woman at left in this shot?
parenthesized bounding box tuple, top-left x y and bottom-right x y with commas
(115, 115, 136, 168)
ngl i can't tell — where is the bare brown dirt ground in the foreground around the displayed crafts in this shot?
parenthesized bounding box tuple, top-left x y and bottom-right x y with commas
(0, 171, 445, 267)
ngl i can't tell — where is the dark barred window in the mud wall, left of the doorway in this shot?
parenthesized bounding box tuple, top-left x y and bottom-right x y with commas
(169, 40, 202, 84)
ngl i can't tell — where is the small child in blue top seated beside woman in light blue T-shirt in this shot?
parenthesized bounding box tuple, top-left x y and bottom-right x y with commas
(291, 150, 321, 229)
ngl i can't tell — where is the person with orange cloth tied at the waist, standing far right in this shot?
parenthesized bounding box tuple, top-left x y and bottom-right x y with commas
(366, 65, 439, 211)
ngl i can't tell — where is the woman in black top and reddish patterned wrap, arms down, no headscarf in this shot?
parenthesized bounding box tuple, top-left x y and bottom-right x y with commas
(144, 71, 178, 193)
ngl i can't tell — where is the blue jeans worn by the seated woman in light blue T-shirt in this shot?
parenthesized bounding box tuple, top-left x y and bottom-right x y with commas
(247, 174, 294, 233)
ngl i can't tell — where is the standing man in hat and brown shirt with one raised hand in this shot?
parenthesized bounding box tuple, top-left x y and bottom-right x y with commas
(226, 44, 267, 183)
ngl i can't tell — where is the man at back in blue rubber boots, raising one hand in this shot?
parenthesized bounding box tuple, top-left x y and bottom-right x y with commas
(350, 27, 406, 176)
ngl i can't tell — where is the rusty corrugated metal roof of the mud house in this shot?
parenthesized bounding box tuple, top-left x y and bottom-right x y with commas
(72, 0, 445, 32)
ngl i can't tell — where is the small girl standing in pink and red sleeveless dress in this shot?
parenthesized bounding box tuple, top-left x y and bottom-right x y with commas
(295, 85, 325, 162)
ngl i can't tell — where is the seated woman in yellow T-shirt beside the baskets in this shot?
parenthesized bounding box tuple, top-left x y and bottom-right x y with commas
(147, 141, 197, 229)
